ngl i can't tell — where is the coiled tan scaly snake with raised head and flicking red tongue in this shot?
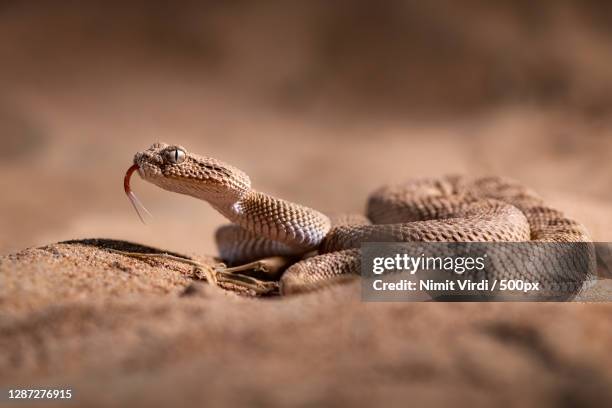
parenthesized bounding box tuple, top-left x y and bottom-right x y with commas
(124, 143, 593, 295)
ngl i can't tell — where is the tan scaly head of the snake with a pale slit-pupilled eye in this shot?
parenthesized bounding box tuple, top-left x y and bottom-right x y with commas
(134, 143, 251, 205)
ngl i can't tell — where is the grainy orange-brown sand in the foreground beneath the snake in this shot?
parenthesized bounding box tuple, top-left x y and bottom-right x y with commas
(0, 241, 612, 406)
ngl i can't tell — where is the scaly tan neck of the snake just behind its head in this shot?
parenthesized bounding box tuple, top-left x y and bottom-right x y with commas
(211, 190, 331, 251)
